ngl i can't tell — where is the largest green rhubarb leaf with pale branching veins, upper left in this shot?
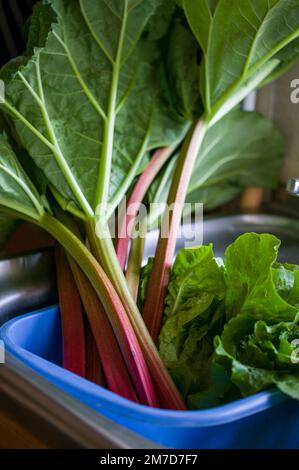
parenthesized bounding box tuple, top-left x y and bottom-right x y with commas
(4, 0, 186, 220)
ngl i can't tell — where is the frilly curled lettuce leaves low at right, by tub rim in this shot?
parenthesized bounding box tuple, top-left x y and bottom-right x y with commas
(215, 314, 299, 399)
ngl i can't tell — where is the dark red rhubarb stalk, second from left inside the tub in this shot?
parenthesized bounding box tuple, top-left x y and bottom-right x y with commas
(70, 259, 138, 402)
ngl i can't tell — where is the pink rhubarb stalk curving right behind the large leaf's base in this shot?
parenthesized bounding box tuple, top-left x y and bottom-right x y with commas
(116, 146, 175, 271)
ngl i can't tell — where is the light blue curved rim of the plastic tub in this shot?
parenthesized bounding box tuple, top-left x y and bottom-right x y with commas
(0, 305, 289, 428)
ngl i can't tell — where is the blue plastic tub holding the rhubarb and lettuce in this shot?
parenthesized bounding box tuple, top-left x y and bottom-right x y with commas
(0, 306, 299, 449)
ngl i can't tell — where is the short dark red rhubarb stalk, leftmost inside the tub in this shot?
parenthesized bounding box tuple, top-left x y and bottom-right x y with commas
(55, 244, 85, 377)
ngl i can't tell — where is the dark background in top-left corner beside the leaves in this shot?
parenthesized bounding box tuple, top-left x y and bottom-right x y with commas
(0, 0, 35, 67)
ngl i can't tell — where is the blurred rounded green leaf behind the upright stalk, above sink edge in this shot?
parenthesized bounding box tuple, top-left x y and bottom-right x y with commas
(149, 109, 283, 224)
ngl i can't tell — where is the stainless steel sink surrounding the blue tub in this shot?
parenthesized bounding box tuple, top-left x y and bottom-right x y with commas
(0, 214, 299, 449)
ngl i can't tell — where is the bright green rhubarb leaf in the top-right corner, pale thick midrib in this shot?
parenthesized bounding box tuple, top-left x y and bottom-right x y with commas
(184, 0, 299, 122)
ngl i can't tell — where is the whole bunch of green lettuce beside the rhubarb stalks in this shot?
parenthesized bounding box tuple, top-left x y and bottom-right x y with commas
(159, 233, 299, 408)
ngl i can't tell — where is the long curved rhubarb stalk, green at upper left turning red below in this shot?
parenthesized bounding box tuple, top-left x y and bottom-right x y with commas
(43, 213, 159, 407)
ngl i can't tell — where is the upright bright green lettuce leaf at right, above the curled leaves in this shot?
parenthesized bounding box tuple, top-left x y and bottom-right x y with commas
(225, 233, 297, 321)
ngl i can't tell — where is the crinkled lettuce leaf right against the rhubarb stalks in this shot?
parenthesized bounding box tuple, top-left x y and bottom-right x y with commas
(159, 245, 225, 398)
